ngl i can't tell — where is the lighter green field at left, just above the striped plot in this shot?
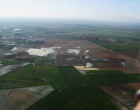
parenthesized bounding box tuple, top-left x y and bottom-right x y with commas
(0, 64, 67, 89)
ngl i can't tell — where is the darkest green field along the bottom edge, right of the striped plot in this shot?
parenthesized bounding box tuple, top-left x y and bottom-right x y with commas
(27, 85, 117, 110)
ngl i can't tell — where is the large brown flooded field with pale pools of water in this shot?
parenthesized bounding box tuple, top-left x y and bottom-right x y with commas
(11, 39, 140, 73)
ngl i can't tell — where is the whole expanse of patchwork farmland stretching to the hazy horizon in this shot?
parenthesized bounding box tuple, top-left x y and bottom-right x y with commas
(0, 20, 140, 110)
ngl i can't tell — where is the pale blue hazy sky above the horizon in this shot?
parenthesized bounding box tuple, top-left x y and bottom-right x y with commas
(0, 0, 140, 23)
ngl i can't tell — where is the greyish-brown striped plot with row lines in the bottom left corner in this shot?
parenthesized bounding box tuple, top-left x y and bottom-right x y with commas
(0, 86, 54, 110)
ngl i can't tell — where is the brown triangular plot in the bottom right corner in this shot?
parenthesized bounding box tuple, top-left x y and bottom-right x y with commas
(100, 84, 140, 110)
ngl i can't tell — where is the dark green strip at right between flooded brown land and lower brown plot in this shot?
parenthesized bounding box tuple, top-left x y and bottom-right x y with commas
(86, 70, 140, 85)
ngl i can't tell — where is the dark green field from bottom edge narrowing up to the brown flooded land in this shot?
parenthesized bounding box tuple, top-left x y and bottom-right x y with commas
(27, 67, 117, 110)
